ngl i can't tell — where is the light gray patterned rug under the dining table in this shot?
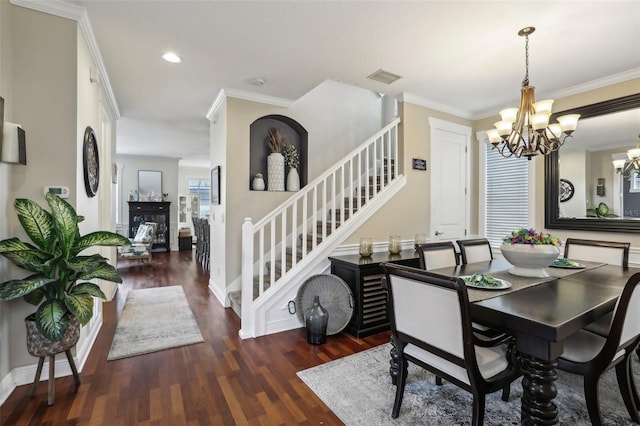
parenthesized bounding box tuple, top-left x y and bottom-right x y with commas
(298, 345, 640, 426)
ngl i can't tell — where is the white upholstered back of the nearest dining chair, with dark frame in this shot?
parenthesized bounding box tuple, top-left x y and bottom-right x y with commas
(382, 263, 479, 385)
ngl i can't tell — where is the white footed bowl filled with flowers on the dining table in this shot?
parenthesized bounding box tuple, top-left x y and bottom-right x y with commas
(500, 228, 560, 278)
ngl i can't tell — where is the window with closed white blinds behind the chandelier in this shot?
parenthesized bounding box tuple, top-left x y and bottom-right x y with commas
(480, 143, 534, 247)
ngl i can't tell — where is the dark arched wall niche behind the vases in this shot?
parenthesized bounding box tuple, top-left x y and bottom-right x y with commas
(249, 115, 309, 189)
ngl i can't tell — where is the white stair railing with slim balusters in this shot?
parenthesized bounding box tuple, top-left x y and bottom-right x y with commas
(242, 118, 400, 323)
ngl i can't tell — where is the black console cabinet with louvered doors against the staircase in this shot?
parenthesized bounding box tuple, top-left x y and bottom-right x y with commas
(329, 250, 420, 338)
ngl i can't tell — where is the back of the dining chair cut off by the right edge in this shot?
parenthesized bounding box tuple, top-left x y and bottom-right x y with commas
(598, 272, 640, 356)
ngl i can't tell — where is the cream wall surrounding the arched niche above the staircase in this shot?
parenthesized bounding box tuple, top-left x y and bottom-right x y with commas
(220, 81, 382, 296)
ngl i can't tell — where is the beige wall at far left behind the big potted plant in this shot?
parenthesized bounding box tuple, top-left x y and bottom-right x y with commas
(0, 1, 119, 401)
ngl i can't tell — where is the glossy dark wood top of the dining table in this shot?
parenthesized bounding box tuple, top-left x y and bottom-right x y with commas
(438, 259, 640, 360)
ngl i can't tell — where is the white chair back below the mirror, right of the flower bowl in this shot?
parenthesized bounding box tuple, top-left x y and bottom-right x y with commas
(564, 238, 631, 269)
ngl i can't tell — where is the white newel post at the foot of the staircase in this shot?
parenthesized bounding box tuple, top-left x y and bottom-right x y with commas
(239, 217, 256, 339)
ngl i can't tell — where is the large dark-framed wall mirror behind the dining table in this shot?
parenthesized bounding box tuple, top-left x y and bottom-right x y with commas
(545, 94, 640, 232)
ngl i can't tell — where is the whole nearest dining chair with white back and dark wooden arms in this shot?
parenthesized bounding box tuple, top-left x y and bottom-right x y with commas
(382, 264, 520, 425)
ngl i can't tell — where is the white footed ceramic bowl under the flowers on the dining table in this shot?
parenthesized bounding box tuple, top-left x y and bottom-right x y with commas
(500, 244, 560, 278)
